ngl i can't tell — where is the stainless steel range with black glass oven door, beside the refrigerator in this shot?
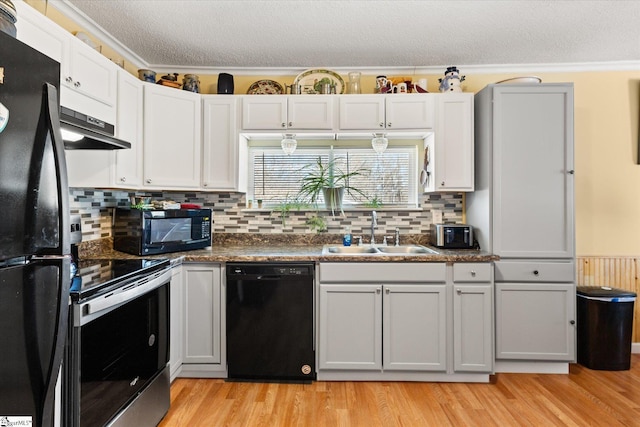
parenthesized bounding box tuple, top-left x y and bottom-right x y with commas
(64, 259, 171, 427)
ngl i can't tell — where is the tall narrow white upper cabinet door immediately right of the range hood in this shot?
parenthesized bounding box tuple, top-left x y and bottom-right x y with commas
(114, 70, 143, 188)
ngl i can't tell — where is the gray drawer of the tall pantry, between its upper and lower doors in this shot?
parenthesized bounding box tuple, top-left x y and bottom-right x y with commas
(495, 261, 575, 282)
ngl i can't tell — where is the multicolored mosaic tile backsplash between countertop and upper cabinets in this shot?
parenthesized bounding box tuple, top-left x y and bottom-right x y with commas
(69, 188, 463, 241)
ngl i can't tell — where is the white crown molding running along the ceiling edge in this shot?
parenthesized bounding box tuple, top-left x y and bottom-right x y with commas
(50, 0, 640, 76)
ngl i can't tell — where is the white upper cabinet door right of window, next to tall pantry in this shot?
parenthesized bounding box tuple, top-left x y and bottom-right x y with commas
(432, 93, 474, 191)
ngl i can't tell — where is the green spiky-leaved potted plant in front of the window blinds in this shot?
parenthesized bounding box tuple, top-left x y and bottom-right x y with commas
(298, 153, 366, 215)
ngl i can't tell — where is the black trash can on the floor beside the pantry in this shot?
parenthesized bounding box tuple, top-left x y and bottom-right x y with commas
(576, 286, 636, 371)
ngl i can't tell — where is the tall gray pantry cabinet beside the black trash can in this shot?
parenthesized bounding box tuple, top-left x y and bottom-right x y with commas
(467, 83, 575, 372)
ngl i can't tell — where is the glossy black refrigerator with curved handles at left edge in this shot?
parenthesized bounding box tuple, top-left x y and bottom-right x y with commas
(0, 32, 70, 426)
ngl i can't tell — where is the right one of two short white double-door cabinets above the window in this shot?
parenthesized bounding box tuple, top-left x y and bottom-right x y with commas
(339, 94, 435, 131)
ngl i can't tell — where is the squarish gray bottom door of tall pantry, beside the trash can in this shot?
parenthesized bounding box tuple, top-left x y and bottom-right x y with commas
(496, 283, 576, 361)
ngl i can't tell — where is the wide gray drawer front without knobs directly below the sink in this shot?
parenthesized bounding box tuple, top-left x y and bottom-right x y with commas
(320, 262, 446, 283)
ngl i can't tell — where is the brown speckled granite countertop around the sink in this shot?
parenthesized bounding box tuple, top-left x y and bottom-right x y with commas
(80, 234, 499, 263)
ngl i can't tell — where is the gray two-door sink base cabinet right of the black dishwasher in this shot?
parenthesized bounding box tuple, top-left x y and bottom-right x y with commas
(318, 263, 447, 371)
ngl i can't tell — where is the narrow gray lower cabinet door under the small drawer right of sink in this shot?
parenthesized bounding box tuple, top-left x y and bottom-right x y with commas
(453, 284, 493, 372)
